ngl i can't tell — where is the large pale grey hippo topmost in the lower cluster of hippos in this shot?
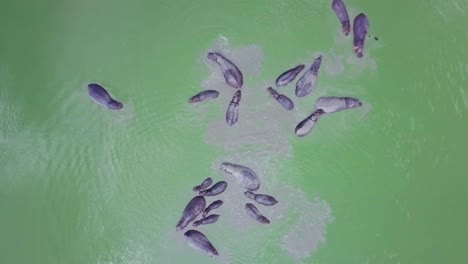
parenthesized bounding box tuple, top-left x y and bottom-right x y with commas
(220, 162, 260, 191)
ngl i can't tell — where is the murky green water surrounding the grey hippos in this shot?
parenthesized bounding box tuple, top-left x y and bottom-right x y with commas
(0, 0, 468, 264)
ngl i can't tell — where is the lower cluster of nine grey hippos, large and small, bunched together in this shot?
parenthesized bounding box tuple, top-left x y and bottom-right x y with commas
(176, 162, 278, 257)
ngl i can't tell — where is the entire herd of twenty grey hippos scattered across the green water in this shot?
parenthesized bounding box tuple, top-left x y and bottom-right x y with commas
(84, 0, 377, 257)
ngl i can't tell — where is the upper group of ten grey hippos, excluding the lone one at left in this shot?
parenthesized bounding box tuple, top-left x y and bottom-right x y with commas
(188, 0, 369, 137)
